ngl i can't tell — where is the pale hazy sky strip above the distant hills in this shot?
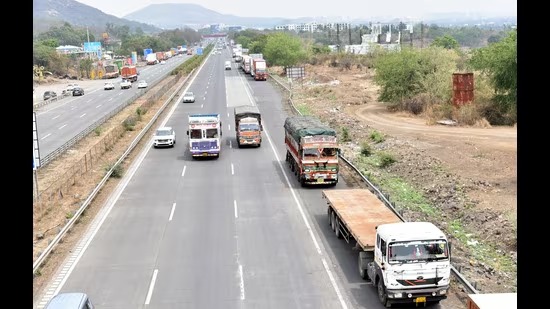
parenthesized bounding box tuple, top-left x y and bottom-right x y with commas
(76, 0, 517, 18)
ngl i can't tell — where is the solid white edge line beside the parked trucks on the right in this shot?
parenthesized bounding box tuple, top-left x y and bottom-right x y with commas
(243, 74, 348, 309)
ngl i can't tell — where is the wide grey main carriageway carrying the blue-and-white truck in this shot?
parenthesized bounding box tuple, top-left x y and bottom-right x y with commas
(35, 50, 444, 309)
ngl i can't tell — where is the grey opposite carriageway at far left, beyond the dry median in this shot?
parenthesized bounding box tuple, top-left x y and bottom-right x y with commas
(36, 55, 191, 158)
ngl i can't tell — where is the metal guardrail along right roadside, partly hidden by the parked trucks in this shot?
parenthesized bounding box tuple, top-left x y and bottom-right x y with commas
(269, 70, 479, 294)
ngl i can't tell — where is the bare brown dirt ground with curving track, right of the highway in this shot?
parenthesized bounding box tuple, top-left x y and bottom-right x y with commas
(284, 65, 517, 293)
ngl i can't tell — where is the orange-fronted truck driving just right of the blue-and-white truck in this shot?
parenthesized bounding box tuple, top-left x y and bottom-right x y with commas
(234, 105, 263, 148)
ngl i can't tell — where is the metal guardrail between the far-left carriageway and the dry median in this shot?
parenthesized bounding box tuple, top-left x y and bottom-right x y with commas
(38, 73, 168, 168)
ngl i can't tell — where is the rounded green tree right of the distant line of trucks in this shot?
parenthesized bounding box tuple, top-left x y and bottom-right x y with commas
(263, 32, 306, 68)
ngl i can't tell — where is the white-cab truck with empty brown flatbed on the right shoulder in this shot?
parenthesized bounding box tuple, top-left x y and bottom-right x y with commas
(322, 189, 451, 308)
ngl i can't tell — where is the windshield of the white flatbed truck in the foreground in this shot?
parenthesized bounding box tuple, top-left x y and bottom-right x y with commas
(388, 239, 449, 264)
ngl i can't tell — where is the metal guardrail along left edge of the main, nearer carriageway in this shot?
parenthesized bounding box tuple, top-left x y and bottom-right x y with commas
(32, 69, 195, 275)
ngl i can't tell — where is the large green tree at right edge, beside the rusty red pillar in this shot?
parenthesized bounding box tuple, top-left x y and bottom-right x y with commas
(468, 30, 518, 109)
